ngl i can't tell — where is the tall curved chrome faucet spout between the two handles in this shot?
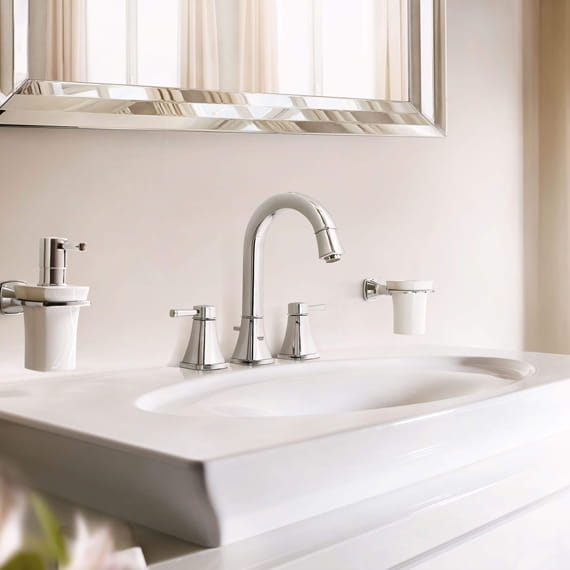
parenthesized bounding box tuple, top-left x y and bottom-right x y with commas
(232, 192, 344, 365)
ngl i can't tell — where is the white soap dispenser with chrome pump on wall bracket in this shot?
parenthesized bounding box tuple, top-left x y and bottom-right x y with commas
(0, 237, 89, 372)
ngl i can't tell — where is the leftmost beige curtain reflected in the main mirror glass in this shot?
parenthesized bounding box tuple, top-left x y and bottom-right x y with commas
(44, 0, 87, 81)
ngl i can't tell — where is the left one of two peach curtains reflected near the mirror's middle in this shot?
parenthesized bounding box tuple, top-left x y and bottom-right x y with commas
(180, 0, 220, 90)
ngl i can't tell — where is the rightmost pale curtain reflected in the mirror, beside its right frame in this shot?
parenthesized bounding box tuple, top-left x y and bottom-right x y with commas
(373, 0, 408, 101)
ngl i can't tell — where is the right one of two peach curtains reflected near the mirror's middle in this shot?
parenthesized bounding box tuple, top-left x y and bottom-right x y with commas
(239, 0, 278, 93)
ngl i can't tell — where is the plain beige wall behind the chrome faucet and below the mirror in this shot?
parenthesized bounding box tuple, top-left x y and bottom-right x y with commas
(0, 0, 535, 366)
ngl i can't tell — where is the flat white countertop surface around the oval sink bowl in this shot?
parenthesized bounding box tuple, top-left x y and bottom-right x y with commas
(0, 346, 570, 461)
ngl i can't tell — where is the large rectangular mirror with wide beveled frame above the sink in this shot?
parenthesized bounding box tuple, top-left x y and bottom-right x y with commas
(0, 0, 445, 136)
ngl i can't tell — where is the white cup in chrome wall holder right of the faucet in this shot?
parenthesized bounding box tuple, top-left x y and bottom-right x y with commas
(362, 279, 434, 334)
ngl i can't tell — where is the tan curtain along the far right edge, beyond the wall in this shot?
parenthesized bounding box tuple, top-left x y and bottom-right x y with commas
(539, 0, 570, 353)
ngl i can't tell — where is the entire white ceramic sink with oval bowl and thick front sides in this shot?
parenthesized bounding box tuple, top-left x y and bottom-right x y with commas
(0, 348, 570, 546)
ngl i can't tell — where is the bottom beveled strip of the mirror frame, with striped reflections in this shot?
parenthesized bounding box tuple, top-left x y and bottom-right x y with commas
(0, 79, 444, 137)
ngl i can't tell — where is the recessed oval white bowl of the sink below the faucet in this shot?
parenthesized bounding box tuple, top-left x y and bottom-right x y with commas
(138, 357, 534, 417)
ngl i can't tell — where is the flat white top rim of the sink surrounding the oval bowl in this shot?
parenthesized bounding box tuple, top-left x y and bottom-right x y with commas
(0, 345, 560, 464)
